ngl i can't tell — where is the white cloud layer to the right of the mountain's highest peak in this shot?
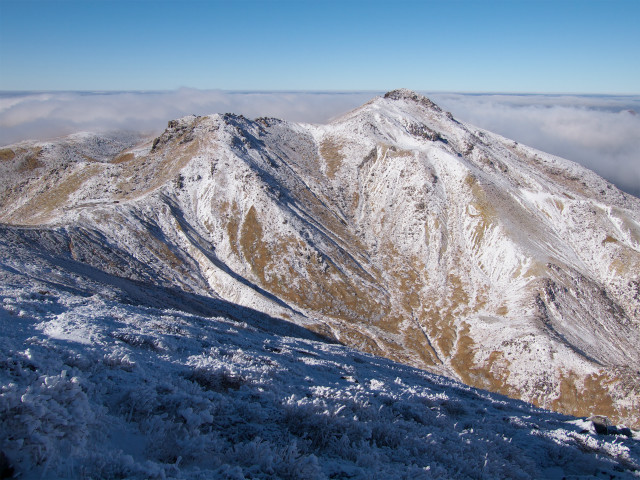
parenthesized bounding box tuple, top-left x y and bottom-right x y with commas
(431, 94, 640, 196)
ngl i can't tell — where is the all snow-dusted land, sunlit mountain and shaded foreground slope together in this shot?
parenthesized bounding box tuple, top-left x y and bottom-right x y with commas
(0, 90, 640, 479)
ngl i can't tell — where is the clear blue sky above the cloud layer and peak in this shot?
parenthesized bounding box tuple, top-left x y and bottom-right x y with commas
(0, 0, 640, 94)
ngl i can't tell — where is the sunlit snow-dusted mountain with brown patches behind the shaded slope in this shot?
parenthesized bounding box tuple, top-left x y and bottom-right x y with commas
(0, 90, 640, 427)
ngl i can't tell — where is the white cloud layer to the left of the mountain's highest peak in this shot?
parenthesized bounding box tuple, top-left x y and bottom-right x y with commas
(0, 88, 375, 145)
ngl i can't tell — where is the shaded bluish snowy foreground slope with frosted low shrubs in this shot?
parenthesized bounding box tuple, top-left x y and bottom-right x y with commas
(0, 232, 640, 479)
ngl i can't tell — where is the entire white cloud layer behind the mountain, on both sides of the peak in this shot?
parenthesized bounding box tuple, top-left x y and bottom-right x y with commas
(0, 88, 640, 197)
